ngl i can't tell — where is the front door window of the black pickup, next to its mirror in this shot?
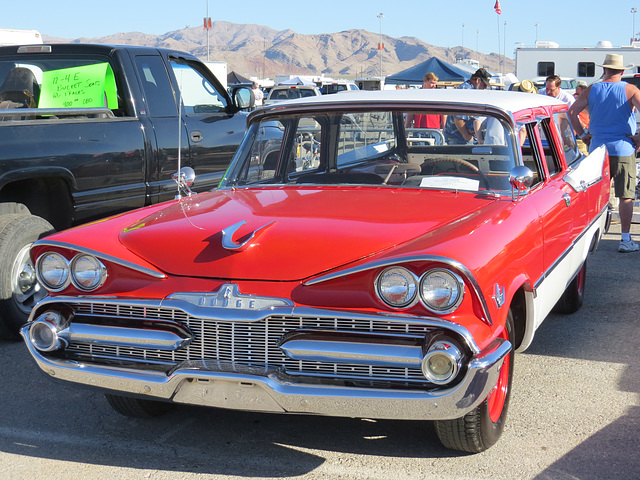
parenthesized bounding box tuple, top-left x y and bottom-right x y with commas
(171, 59, 227, 115)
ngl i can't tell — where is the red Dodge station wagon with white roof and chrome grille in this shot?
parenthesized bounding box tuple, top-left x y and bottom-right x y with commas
(21, 90, 610, 452)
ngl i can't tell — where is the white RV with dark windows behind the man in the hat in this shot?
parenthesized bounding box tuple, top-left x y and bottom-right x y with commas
(516, 41, 640, 84)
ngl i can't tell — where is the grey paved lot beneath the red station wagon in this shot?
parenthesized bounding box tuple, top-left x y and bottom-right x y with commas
(0, 225, 640, 480)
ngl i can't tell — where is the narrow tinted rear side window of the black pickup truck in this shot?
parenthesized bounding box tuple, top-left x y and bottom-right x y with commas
(135, 55, 178, 117)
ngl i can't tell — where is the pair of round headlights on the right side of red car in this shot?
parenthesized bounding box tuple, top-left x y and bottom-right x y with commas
(376, 267, 464, 314)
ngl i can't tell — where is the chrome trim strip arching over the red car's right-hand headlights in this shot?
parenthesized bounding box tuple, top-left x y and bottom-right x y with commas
(302, 255, 493, 325)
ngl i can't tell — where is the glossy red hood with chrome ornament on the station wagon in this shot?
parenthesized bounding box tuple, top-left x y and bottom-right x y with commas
(120, 187, 487, 281)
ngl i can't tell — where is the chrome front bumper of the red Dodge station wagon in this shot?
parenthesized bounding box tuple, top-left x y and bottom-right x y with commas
(21, 324, 512, 420)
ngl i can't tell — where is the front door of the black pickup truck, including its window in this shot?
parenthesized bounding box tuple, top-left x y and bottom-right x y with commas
(170, 57, 246, 191)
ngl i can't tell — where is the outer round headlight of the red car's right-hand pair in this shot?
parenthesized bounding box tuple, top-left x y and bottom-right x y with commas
(420, 268, 464, 313)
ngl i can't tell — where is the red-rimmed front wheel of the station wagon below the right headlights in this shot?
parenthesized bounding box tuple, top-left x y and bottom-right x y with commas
(435, 310, 514, 453)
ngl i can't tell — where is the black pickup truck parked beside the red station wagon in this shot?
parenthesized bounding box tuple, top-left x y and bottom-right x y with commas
(0, 44, 252, 338)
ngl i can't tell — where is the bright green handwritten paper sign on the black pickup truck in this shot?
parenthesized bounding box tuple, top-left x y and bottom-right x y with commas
(38, 62, 118, 109)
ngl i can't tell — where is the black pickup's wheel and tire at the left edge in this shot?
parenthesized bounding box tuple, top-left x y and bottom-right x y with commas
(0, 214, 54, 339)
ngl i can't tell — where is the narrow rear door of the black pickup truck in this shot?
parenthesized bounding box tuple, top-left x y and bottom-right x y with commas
(134, 55, 191, 203)
